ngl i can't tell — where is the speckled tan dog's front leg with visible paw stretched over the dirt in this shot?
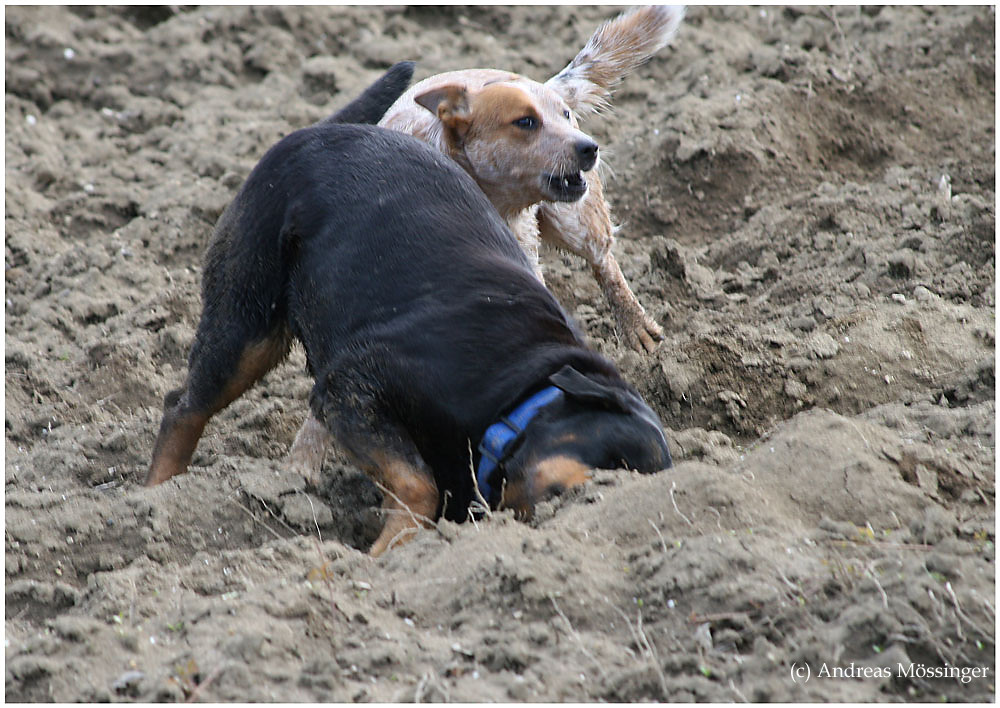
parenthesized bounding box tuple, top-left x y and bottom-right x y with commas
(538, 172, 663, 352)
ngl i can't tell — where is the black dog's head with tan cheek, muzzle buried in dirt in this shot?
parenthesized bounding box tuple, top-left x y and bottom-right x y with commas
(501, 366, 672, 517)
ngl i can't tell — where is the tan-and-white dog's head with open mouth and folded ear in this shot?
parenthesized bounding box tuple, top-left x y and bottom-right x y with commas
(415, 74, 598, 212)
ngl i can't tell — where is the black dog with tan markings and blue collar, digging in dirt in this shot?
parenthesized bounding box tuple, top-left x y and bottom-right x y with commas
(146, 67, 671, 555)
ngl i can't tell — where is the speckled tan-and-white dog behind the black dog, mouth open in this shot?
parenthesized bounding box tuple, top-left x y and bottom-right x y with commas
(380, 6, 684, 352)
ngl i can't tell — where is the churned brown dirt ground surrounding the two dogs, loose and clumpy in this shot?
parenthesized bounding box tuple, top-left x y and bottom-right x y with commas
(4, 6, 996, 702)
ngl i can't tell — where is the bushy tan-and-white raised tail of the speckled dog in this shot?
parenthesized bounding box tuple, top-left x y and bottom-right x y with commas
(545, 5, 684, 113)
